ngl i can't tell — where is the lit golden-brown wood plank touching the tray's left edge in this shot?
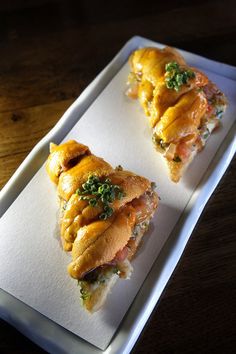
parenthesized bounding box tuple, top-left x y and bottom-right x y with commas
(0, 99, 74, 189)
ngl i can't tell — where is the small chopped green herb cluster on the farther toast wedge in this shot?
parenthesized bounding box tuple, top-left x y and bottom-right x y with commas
(165, 61, 195, 91)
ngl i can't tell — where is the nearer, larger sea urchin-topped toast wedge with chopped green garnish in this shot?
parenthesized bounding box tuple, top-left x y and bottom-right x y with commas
(46, 140, 158, 312)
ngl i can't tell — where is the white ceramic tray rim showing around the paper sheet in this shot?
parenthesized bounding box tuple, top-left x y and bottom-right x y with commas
(0, 37, 236, 354)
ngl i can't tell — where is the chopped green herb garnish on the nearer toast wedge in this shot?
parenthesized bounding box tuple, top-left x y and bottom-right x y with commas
(76, 175, 125, 220)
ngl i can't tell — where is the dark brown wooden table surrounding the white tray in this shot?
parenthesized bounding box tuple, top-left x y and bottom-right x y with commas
(0, 0, 236, 354)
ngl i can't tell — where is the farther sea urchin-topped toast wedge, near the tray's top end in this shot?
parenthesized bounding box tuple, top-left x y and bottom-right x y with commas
(127, 47, 227, 182)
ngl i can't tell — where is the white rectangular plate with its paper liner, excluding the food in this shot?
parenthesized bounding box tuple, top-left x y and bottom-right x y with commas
(0, 37, 236, 353)
